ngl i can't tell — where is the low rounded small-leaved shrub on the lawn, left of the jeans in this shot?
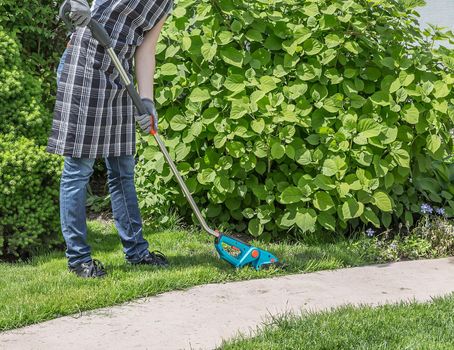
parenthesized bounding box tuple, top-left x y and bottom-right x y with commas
(0, 135, 62, 259)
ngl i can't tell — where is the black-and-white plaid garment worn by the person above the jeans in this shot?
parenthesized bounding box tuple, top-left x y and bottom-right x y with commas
(47, 0, 173, 158)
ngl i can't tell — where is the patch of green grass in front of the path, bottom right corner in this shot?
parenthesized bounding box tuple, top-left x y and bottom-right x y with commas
(220, 294, 454, 350)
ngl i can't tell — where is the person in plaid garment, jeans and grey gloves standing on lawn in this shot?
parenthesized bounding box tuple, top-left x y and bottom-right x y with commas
(47, 0, 173, 278)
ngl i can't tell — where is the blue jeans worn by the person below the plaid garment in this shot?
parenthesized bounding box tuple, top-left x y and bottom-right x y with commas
(60, 156, 148, 267)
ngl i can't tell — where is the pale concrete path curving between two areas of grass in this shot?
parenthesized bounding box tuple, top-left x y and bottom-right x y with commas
(0, 258, 454, 350)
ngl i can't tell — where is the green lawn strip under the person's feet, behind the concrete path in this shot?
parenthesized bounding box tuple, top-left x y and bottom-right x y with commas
(0, 221, 369, 330)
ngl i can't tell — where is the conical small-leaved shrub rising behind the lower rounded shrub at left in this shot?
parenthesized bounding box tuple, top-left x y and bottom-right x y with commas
(0, 30, 51, 145)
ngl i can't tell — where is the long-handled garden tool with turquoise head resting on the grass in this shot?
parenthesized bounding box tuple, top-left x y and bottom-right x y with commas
(60, 8, 281, 270)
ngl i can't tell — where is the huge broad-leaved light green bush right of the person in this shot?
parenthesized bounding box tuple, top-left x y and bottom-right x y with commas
(137, 0, 454, 239)
